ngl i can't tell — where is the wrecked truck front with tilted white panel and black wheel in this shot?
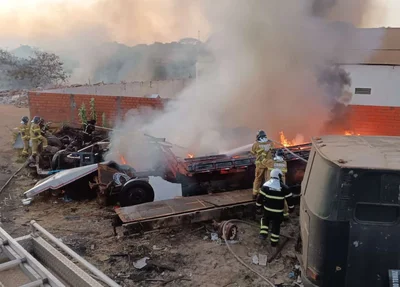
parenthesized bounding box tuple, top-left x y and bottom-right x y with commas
(24, 161, 154, 206)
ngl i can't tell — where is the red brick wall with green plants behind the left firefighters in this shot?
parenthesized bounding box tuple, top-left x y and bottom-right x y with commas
(29, 92, 166, 124)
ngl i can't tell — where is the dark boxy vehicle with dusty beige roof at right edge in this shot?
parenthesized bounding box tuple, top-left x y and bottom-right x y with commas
(300, 136, 400, 287)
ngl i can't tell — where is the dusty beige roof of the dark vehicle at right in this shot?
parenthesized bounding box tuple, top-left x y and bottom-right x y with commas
(312, 135, 400, 170)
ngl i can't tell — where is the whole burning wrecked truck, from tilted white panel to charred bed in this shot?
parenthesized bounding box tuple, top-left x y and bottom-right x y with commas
(25, 133, 311, 206)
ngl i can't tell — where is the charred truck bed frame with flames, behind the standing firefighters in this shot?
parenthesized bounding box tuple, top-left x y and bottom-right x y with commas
(160, 143, 311, 196)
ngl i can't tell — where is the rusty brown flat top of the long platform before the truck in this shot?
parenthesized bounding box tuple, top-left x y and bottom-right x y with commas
(115, 190, 252, 223)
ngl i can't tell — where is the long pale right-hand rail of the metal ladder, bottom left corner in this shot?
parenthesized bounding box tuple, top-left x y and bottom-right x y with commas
(31, 220, 121, 287)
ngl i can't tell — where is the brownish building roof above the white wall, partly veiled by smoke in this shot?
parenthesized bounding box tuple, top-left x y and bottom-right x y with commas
(341, 28, 400, 65)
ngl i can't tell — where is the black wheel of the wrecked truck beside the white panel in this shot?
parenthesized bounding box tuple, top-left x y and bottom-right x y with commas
(119, 181, 154, 207)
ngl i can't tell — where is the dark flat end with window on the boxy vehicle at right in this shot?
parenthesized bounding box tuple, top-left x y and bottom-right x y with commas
(346, 171, 400, 287)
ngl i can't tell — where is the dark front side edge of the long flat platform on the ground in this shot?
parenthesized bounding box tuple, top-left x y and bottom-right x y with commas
(122, 202, 255, 235)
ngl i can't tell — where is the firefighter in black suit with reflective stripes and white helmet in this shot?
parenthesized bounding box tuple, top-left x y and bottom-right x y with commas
(256, 169, 294, 247)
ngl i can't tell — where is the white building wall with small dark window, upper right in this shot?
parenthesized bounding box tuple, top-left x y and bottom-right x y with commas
(342, 65, 400, 107)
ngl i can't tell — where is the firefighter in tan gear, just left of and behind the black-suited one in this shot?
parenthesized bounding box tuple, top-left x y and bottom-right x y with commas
(251, 130, 273, 199)
